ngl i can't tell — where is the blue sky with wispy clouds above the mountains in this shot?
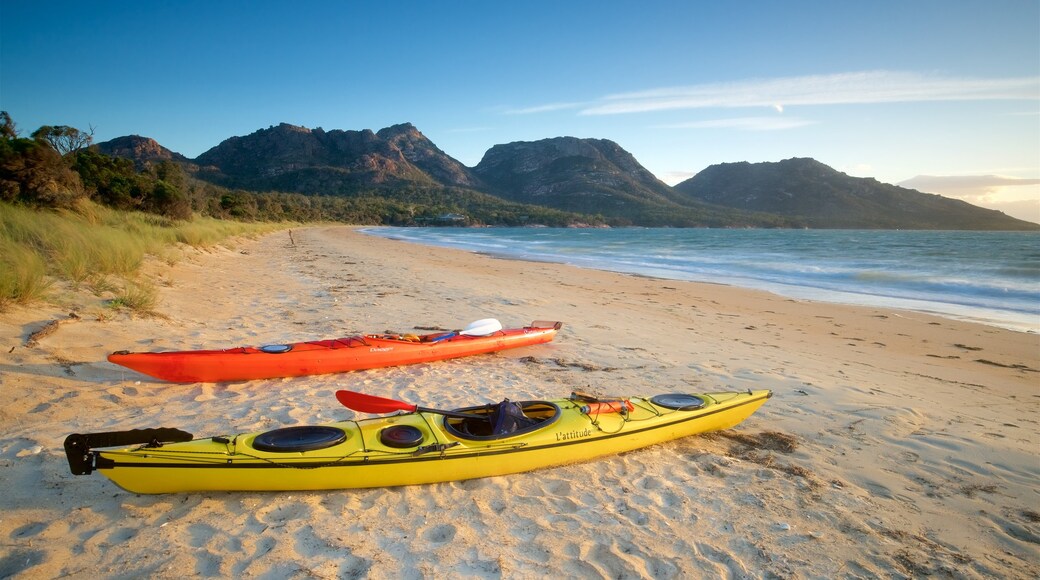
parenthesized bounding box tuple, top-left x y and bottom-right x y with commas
(0, 0, 1040, 221)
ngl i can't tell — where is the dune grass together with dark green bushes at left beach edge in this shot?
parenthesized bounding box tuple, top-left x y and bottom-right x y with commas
(0, 111, 301, 312)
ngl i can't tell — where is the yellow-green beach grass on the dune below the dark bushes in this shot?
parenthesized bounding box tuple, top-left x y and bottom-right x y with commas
(0, 202, 291, 310)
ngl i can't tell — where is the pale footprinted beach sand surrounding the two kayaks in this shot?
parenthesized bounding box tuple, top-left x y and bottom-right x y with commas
(0, 228, 1040, 578)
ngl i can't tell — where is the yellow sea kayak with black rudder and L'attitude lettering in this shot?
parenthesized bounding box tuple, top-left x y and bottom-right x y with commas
(64, 390, 773, 494)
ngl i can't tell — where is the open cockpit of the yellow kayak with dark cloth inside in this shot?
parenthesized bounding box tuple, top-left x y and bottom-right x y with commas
(444, 399, 560, 441)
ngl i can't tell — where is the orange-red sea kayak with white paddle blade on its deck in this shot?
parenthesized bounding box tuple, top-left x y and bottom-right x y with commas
(108, 319, 564, 383)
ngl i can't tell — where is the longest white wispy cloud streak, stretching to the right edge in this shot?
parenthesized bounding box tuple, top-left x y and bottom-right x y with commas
(505, 71, 1040, 115)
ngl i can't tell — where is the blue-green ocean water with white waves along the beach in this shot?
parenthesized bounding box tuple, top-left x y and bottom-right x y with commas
(362, 228, 1040, 333)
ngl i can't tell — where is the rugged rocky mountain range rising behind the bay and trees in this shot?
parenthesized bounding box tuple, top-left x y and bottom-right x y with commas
(97, 123, 1040, 230)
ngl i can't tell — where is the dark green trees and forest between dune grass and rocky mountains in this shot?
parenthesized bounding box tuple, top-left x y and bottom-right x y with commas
(0, 112, 602, 226)
